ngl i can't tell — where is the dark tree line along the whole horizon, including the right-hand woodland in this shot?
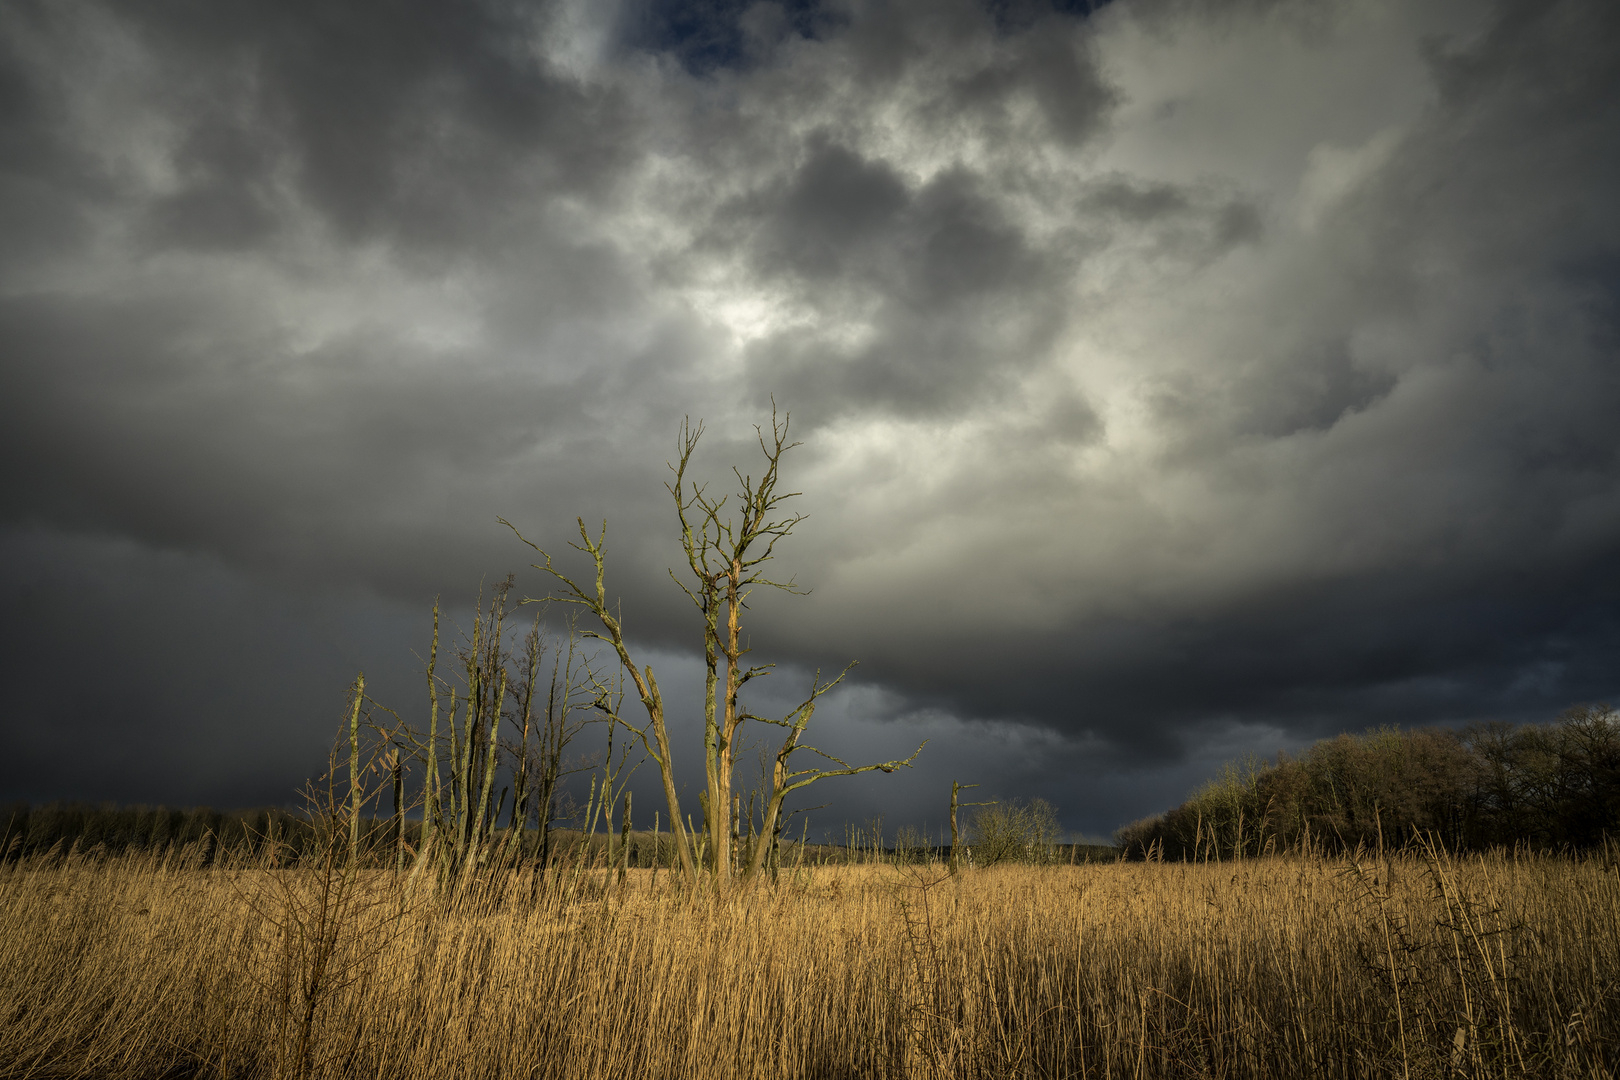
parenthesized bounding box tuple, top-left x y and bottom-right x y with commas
(0, 706, 1620, 868)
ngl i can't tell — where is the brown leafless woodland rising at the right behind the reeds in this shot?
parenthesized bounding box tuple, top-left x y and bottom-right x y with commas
(1115, 706, 1620, 860)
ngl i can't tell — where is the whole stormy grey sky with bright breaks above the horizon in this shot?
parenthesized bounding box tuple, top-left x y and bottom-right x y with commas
(0, 0, 1620, 836)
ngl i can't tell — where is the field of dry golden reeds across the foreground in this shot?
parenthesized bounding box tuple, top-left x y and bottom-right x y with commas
(0, 852, 1620, 1080)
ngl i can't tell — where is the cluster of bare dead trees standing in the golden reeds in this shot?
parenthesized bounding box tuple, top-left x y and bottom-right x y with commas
(324, 404, 922, 889)
